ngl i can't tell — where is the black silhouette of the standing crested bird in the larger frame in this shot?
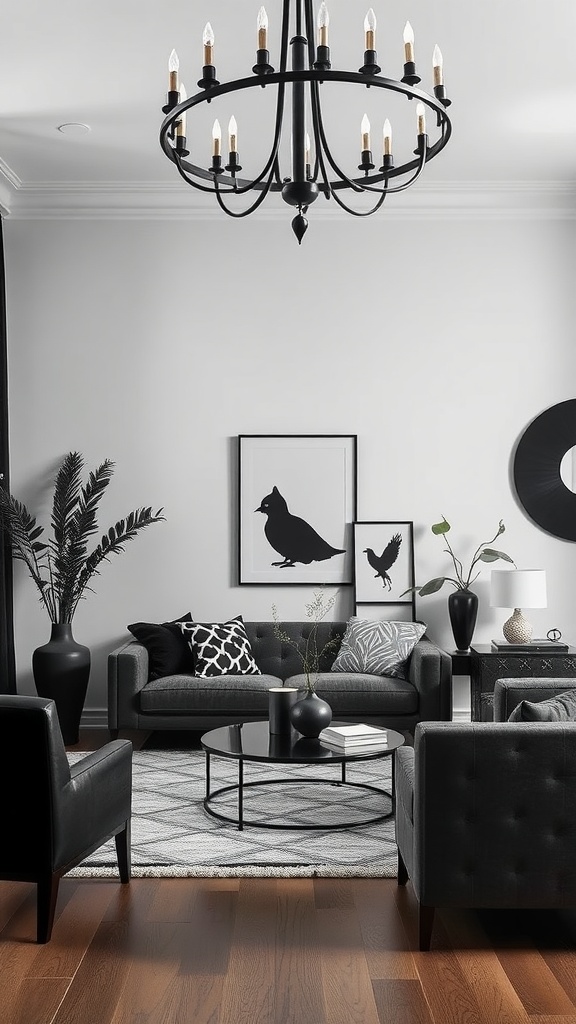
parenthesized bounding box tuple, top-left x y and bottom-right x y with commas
(254, 486, 345, 569)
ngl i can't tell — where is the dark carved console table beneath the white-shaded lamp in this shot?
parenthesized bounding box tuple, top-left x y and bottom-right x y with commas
(469, 643, 576, 722)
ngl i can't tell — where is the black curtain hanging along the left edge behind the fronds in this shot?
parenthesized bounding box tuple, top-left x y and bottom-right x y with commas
(0, 216, 16, 693)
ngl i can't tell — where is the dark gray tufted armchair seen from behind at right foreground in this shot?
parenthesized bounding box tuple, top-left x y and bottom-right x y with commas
(396, 679, 576, 949)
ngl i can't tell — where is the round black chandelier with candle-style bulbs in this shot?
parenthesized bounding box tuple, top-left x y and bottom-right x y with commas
(160, 0, 452, 243)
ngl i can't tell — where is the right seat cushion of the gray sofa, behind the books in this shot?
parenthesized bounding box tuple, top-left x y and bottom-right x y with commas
(286, 672, 418, 719)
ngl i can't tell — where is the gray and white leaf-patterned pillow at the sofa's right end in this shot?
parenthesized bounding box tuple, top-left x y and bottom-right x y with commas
(331, 617, 426, 679)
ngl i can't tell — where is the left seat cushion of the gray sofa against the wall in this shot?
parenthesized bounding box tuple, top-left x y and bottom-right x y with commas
(139, 674, 282, 718)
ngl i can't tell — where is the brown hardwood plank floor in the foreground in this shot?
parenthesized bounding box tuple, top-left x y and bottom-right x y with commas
(0, 732, 576, 1024)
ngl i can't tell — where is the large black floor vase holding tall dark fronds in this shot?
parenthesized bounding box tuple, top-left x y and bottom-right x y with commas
(32, 623, 90, 745)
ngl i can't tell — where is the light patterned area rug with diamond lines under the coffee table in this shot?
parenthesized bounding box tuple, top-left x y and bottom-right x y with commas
(69, 751, 397, 878)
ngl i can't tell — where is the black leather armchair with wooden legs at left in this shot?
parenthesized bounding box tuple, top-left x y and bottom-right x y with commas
(0, 695, 132, 942)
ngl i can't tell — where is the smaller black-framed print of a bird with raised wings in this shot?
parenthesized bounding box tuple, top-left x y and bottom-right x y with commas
(354, 522, 414, 618)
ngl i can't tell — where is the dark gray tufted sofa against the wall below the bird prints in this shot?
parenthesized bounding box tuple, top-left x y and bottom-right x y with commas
(108, 621, 452, 737)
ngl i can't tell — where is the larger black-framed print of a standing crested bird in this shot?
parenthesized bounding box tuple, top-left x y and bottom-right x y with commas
(238, 434, 357, 586)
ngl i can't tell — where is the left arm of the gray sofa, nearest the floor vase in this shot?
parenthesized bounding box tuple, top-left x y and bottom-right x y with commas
(108, 640, 149, 730)
